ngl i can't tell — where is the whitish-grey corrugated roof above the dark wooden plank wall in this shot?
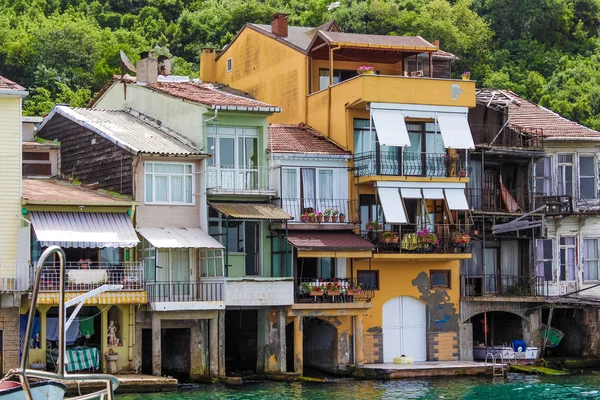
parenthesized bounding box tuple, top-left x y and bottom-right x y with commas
(44, 106, 205, 155)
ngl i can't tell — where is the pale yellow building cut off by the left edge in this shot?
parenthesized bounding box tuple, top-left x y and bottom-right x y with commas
(0, 76, 28, 372)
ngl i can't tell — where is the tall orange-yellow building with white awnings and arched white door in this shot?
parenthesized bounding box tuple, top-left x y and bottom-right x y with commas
(200, 14, 475, 364)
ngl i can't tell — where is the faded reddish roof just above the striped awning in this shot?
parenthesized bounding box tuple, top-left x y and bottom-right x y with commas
(23, 178, 130, 205)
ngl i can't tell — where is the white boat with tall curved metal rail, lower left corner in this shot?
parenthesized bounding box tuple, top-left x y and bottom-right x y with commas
(0, 246, 123, 400)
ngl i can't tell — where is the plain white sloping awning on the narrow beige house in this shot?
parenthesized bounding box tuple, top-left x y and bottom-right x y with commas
(137, 228, 224, 249)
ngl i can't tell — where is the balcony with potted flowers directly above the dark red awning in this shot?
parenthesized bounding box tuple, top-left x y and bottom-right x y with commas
(277, 198, 358, 230)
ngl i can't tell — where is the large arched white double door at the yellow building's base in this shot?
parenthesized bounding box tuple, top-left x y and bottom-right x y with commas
(383, 296, 427, 363)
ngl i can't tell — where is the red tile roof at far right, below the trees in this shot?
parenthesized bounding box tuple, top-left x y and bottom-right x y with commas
(503, 91, 600, 140)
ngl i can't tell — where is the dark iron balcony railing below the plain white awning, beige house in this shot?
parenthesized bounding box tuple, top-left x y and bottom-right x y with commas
(146, 281, 225, 303)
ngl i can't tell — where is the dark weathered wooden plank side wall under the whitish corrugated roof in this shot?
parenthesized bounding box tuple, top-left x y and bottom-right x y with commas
(37, 114, 134, 195)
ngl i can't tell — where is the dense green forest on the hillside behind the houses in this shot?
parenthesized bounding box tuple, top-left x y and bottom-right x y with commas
(0, 0, 600, 130)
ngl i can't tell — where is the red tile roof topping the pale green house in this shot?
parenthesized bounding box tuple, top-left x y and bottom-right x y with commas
(147, 82, 274, 108)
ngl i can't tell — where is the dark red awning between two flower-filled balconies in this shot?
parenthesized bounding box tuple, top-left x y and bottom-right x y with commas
(287, 231, 375, 251)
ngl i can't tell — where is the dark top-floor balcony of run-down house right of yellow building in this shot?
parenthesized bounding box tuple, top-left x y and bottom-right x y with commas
(469, 124, 544, 150)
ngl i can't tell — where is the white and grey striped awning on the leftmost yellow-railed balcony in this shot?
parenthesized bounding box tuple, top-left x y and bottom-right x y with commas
(29, 211, 139, 248)
